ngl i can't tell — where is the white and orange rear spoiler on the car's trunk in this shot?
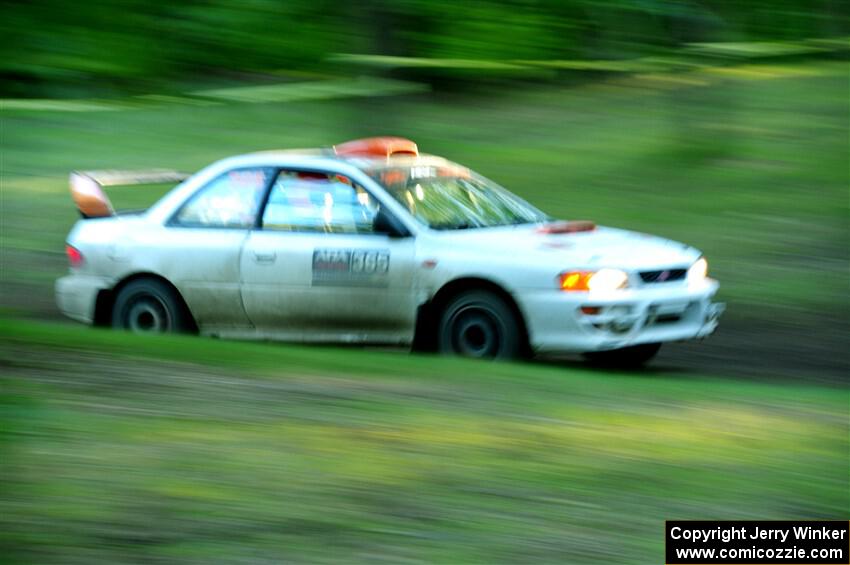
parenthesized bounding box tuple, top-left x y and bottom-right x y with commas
(69, 169, 189, 218)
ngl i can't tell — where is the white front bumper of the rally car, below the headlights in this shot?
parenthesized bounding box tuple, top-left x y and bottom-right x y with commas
(517, 279, 725, 353)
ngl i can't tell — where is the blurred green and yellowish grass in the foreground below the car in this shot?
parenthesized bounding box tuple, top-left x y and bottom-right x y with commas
(0, 320, 850, 564)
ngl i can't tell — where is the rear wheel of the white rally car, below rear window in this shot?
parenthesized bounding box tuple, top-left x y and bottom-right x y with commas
(112, 279, 194, 333)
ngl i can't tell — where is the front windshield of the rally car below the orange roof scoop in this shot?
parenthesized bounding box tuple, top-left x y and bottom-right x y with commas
(372, 165, 550, 230)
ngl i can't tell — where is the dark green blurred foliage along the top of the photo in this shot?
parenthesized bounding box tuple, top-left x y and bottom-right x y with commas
(0, 0, 850, 97)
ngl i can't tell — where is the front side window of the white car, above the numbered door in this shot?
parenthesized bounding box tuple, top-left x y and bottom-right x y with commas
(263, 171, 378, 233)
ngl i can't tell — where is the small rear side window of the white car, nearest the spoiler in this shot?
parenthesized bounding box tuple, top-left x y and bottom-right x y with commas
(176, 169, 271, 228)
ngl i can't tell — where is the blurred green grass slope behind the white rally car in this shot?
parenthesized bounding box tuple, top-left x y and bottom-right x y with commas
(0, 63, 850, 315)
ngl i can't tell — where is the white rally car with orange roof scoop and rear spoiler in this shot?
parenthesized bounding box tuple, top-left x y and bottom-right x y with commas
(56, 137, 723, 364)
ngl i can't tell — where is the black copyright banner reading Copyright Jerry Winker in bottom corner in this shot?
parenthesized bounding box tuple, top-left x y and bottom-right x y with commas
(665, 520, 850, 565)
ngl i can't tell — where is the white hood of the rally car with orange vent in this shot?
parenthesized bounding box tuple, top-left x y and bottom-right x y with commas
(439, 225, 700, 270)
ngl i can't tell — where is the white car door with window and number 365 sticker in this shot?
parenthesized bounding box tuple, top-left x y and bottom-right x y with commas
(241, 170, 416, 342)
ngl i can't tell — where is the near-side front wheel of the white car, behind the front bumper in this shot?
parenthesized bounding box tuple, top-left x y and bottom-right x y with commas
(437, 290, 522, 359)
